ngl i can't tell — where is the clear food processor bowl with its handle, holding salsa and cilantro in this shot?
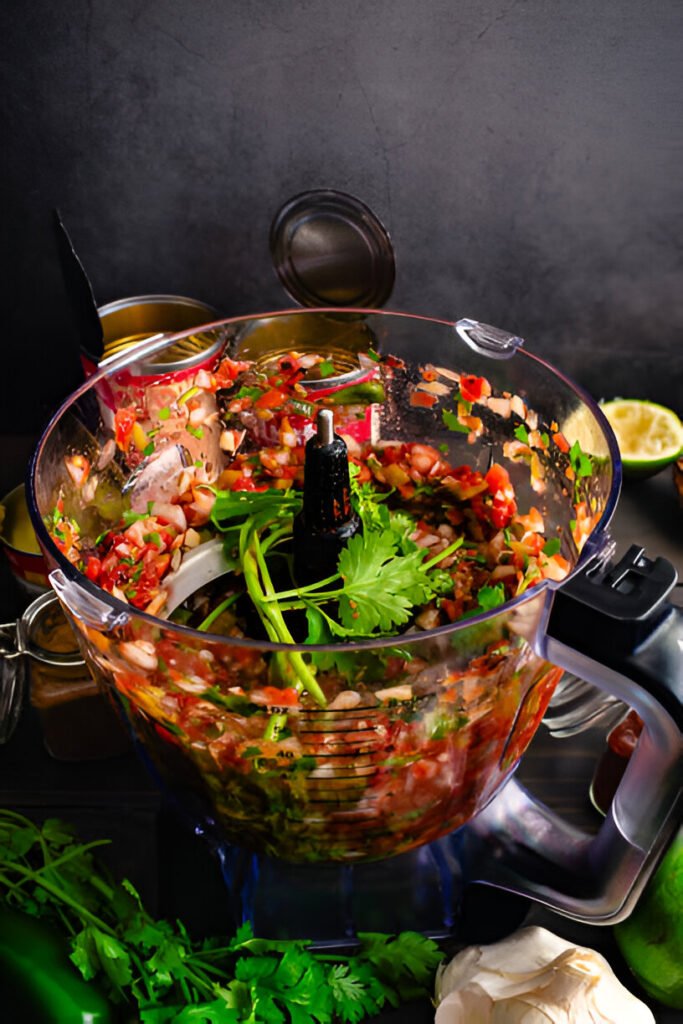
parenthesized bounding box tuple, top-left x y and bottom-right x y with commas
(31, 309, 681, 922)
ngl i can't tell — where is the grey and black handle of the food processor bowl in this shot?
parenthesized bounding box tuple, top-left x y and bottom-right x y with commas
(465, 547, 683, 925)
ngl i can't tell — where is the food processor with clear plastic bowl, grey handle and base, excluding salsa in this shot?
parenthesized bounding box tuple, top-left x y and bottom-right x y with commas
(29, 308, 683, 938)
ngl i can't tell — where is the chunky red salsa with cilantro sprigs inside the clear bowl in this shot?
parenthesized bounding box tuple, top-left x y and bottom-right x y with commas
(48, 339, 595, 860)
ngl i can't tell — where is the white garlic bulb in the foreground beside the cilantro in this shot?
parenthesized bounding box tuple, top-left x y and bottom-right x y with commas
(435, 928, 654, 1024)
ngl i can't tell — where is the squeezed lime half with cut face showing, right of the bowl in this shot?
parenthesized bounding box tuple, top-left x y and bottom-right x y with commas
(600, 398, 683, 477)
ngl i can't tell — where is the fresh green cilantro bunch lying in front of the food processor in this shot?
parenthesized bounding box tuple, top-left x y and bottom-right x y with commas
(0, 811, 441, 1024)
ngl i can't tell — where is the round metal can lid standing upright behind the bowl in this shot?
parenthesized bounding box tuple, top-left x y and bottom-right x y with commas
(270, 188, 395, 309)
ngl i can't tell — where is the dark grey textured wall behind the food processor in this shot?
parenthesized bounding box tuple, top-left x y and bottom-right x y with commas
(0, 0, 683, 431)
